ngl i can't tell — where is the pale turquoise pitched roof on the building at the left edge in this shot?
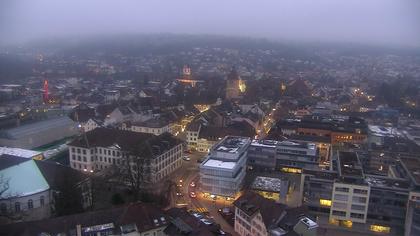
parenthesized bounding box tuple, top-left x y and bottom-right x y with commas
(0, 160, 50, 198)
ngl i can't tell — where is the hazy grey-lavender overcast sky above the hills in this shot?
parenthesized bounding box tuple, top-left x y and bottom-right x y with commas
(0, 0, 420, 46)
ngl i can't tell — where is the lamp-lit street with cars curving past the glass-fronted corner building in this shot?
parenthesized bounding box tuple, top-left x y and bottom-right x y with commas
(170, 152, 237, 235)
